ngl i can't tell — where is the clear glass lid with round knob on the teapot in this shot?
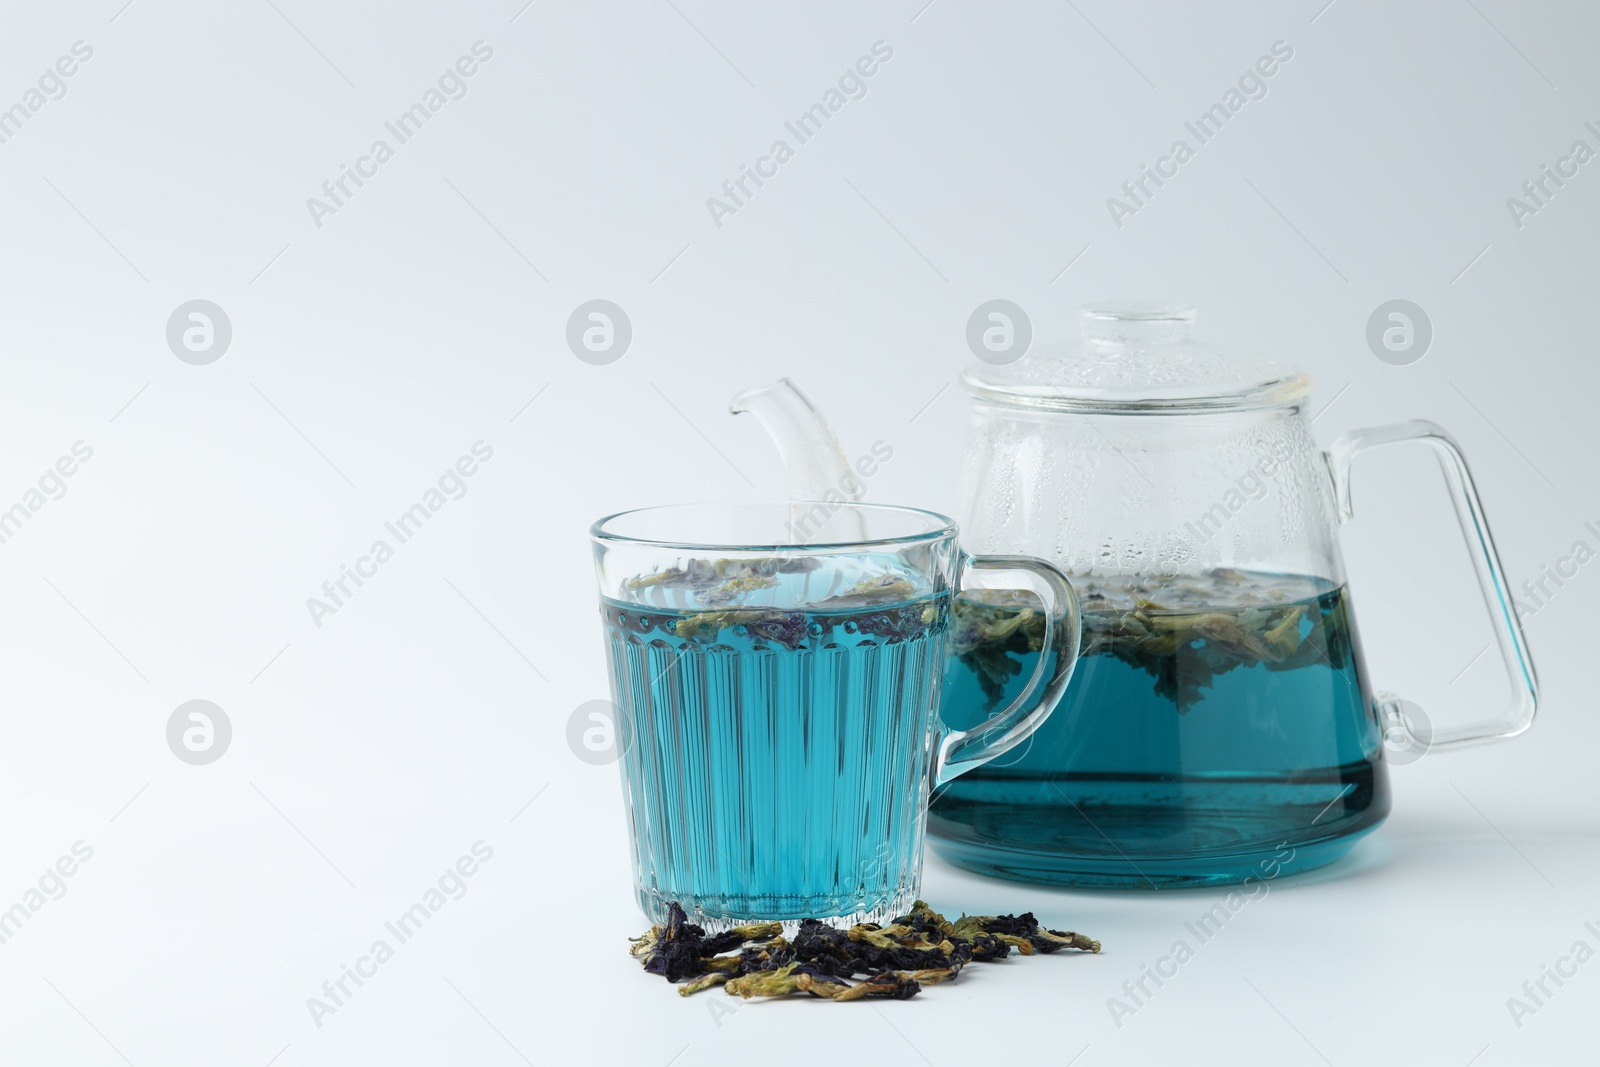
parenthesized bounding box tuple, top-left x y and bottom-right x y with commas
(962, 302, 1310, 413)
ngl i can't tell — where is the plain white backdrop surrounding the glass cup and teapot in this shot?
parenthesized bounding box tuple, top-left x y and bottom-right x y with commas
(0, 0, 1600, 1067)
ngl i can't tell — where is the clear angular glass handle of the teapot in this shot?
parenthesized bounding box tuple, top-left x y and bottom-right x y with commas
(1326, 419, 1539, 753)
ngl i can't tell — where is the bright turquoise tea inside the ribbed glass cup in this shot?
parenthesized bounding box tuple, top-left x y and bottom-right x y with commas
(602, 595, 947, 928)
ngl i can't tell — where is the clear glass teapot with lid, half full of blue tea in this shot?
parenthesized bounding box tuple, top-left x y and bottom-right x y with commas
(733, 304, 1538, 888)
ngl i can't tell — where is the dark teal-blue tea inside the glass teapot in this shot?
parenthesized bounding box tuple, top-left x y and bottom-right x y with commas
(928, 573, 1389, 888)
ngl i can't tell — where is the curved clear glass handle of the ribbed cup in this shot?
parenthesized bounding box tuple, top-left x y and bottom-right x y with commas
(933, 555, 1083, 787)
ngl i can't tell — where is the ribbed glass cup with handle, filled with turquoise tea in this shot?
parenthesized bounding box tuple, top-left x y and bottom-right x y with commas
(590, 501, 1078, 929)
